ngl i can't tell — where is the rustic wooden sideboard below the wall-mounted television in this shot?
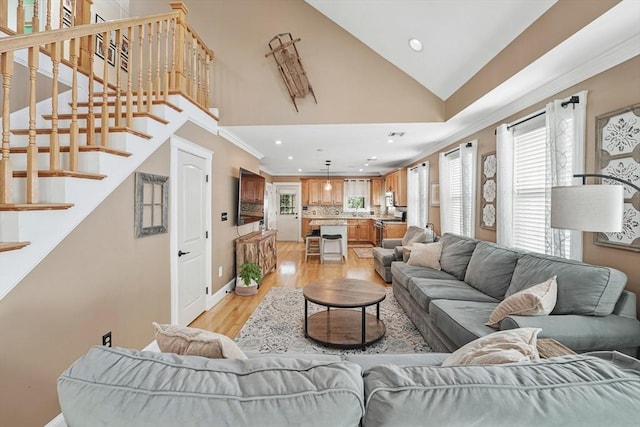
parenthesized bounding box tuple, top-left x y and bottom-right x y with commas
(235, 230, 278, 277)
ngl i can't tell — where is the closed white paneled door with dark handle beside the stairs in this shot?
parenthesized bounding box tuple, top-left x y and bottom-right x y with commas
(173, 150, 208, 325)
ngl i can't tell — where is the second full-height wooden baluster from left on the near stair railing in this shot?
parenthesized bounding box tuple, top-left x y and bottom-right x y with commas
(27, 47, 40, 203)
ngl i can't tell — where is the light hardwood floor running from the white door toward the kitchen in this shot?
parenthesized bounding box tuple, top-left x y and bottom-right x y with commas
(189, 242, 388, 338)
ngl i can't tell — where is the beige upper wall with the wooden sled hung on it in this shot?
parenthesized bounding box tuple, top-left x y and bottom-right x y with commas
(130, 0, 444, 126)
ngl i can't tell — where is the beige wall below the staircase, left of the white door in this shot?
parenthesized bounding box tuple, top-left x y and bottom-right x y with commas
(0, 145, 170, 426)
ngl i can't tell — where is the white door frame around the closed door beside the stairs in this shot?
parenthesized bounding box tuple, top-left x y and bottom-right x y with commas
(169, 135, 213, 324)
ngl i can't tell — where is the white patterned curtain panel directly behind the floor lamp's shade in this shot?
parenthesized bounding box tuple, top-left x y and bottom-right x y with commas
(545, 91, 587, 261)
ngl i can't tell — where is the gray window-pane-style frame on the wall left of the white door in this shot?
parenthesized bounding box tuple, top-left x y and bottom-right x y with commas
(135, 172, 169, 237)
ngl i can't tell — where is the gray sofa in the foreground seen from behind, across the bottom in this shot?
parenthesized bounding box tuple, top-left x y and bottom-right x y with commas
(58, 347, 640, 427)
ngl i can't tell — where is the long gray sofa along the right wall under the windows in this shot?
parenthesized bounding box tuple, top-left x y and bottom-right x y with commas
(391, 234, 640, 356)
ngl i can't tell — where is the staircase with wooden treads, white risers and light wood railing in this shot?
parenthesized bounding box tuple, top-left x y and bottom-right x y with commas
(0, 3, 217, 299)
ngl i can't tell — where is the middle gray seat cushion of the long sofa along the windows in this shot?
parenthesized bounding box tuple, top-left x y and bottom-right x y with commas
(407, 278, 499, 312)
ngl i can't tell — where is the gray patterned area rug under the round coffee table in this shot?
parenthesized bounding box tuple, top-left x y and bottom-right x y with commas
(235, 288, 431, 354)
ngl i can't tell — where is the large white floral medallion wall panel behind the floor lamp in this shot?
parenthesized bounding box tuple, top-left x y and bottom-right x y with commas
(594, 104, 640, 252)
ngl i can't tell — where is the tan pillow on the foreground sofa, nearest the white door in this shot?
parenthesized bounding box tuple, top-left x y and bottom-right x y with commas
(152, 322, 247, 359)
